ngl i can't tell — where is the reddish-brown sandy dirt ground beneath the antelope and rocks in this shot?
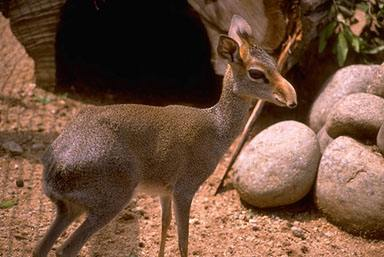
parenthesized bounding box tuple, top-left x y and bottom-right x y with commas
(0, 13, 384, 257)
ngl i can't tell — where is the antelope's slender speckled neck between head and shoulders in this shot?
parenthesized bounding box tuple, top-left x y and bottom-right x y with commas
(212, 65, 251, 144)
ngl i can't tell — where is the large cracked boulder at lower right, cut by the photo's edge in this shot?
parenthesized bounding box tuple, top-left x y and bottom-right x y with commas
(315, 136, 384, 236)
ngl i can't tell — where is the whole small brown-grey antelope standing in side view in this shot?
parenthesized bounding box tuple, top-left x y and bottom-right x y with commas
(33, 15, 296, 257)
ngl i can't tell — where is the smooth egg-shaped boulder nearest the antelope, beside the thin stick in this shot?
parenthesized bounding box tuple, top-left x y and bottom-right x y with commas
(233, 121, 320, 208)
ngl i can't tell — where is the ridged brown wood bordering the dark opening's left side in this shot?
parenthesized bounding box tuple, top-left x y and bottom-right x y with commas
(8, 0, 65, 89)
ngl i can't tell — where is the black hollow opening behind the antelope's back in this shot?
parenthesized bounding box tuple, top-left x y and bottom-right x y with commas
(56, 0, 221, 107)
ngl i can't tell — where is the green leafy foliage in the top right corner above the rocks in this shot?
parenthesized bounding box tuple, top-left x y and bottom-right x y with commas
(319, 0, 384, 66)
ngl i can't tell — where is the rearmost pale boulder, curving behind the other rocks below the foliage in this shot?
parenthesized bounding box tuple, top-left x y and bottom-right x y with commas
(309, 64, 384, 132)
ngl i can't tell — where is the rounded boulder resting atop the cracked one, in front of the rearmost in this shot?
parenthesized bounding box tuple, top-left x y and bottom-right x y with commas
(325, 93, 384, 141)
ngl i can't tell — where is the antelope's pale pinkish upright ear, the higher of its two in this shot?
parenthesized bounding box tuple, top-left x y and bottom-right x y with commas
(228, 14, 252, 46)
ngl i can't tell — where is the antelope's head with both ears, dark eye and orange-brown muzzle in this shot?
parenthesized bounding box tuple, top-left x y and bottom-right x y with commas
(217, 15, 297, 108)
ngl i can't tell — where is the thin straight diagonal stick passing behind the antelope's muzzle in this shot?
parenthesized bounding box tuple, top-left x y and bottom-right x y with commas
(214, 24, 301, 195)
